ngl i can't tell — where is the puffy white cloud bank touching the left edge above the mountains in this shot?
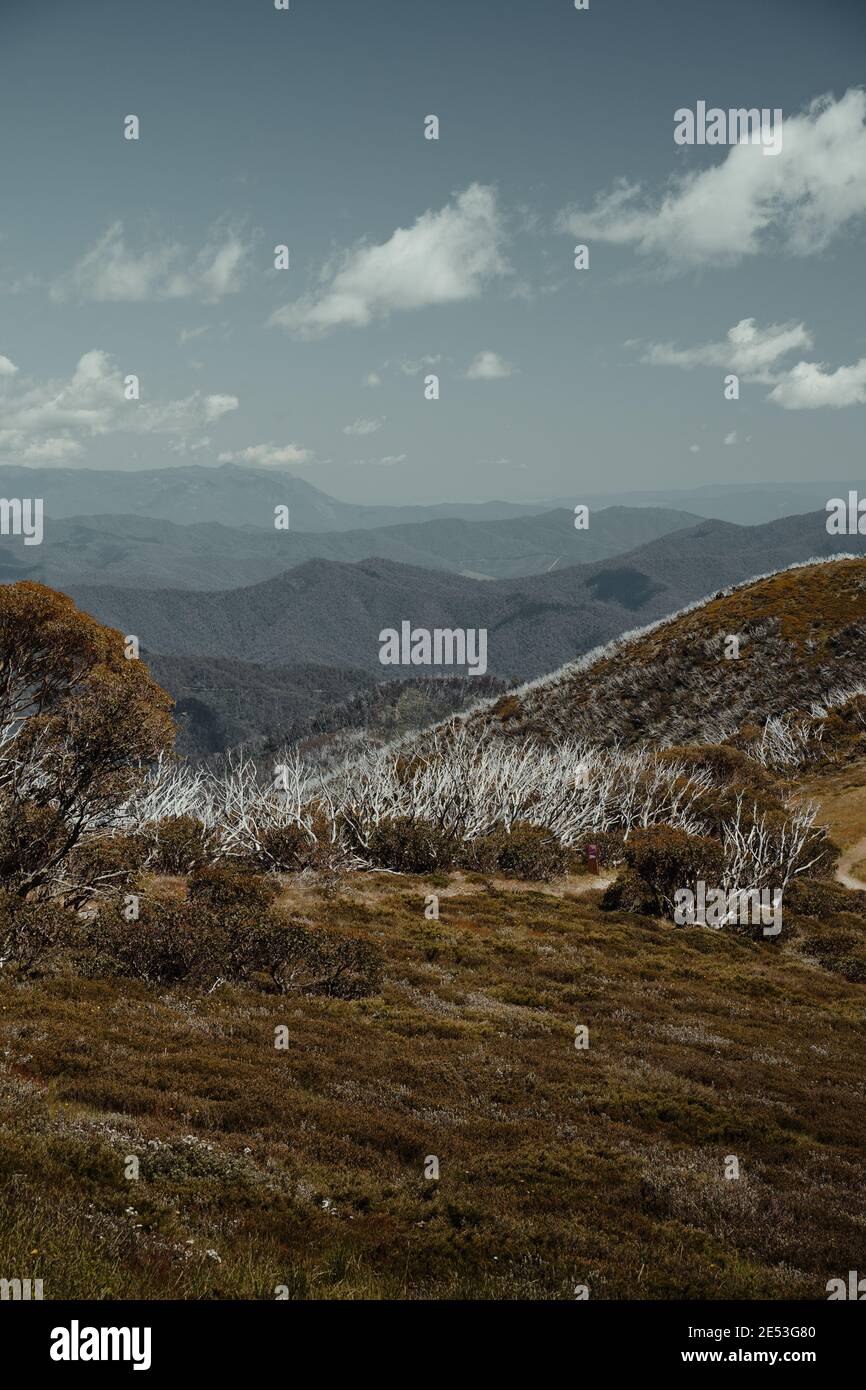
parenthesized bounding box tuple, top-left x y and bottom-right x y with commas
(0, 349, 239, 461)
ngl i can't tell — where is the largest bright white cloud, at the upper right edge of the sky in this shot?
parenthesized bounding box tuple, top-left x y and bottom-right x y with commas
(557, 88, 866, 270)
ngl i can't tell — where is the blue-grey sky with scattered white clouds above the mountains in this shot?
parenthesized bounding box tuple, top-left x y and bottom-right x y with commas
(0, 0, 866, 503)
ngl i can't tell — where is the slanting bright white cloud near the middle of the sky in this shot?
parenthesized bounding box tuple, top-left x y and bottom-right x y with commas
(270, 183, 509, 338)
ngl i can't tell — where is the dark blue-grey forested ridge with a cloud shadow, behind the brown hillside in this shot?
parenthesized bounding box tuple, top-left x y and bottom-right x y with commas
(70, 513, 866, 677)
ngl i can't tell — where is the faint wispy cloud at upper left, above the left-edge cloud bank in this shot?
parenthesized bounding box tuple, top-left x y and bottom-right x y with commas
(51, 221, 249, 303)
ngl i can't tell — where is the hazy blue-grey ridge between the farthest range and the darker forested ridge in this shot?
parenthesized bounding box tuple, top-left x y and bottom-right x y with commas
(0, 507, 699, 589)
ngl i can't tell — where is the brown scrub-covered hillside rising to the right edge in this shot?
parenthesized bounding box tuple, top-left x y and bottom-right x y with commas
(473, 557, 866, 744)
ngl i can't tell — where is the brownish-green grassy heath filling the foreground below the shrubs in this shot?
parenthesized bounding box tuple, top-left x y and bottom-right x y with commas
(0, 874, 866, 1298)
